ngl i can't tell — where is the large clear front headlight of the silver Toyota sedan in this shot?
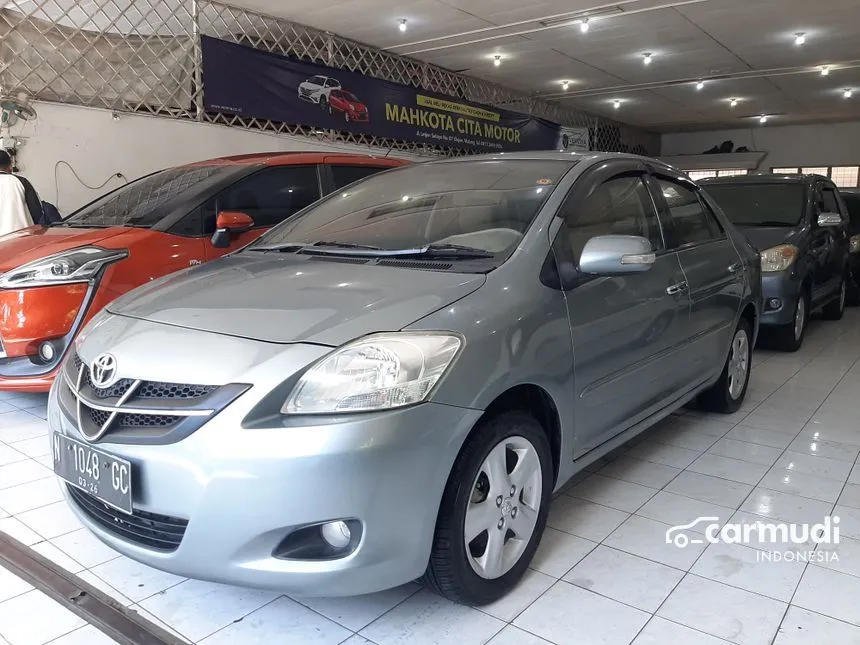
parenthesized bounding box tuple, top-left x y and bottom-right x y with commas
(281, 332, 462, 414)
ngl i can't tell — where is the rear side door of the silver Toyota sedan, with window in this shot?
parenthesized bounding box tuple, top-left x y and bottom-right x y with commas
(652, 172, 744, 385)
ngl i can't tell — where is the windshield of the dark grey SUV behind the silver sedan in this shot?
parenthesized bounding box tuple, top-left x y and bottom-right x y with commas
(705, 183, 806, 226)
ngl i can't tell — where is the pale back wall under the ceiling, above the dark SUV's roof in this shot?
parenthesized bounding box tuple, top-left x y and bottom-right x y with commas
(661, 121, 860, 170)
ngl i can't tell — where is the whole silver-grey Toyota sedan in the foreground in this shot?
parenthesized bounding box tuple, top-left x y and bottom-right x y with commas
(49, 153, 760, 604)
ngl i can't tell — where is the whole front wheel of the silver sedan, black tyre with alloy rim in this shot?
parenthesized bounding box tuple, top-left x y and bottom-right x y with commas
(422, 410, 553, 605)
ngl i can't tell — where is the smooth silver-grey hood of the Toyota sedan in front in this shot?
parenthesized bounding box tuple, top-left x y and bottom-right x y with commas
(108, 253, 485, 346)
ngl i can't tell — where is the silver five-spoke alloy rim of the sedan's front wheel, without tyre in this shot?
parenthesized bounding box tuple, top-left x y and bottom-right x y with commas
(463, 436, 543, 580)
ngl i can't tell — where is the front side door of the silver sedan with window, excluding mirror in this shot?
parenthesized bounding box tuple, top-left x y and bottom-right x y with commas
(554, 161, 689, 456)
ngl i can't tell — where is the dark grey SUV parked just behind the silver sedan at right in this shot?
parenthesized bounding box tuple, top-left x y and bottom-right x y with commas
(700, 174, 848, 351)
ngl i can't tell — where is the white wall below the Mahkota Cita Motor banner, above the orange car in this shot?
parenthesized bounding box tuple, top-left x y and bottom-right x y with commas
(4, 103, 419, 214)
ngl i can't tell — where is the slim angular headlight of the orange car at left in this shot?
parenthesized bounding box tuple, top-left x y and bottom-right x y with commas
(0, 246, 128, 289)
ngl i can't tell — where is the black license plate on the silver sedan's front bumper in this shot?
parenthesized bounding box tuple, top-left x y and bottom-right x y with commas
(52, 432, 132, 515)
